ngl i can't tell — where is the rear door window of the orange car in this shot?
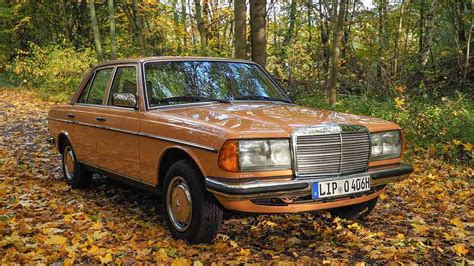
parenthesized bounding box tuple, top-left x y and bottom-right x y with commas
(78, 68, 113, 105)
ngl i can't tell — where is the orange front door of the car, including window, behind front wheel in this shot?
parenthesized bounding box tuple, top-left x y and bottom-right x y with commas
(96, 64, 142, 179)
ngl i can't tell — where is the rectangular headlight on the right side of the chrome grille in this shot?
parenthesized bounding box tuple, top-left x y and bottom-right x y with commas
(370, 130, 402, 160)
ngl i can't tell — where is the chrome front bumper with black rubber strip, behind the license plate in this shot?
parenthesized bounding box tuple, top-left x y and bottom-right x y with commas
(206, 163, 413, 200)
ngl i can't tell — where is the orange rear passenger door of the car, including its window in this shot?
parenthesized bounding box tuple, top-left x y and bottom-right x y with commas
(68, 67, 114, 167)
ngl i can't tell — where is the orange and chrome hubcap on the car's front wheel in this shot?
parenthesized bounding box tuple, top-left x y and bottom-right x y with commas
(166, 176, 193, 232)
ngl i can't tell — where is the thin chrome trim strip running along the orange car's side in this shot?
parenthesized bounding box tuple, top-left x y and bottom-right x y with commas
(48, 118, 218, 153)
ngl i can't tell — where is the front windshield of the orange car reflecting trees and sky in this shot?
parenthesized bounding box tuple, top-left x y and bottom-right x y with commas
(145, 61, 288, 107)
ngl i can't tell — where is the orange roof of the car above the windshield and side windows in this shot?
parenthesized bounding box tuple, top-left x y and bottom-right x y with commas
(96, 56, 255, 67)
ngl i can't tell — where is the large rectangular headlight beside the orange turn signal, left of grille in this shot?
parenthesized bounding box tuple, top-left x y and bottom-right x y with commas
(239, 139, 291, 171)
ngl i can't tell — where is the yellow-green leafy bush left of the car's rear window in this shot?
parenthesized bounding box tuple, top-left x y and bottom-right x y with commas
(8, 43, 96, 101)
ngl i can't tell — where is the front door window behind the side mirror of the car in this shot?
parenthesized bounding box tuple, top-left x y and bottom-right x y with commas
(108, 66, 137, 105)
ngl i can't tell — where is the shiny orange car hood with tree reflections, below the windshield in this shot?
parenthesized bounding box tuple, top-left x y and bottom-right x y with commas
(152, 102, 399, 137)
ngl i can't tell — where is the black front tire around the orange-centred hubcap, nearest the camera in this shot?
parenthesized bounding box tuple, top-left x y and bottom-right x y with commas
(163, 160, 223, 244)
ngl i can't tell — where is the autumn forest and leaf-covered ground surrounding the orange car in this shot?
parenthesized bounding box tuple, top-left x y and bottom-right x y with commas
(0, 0, 474, 265)
